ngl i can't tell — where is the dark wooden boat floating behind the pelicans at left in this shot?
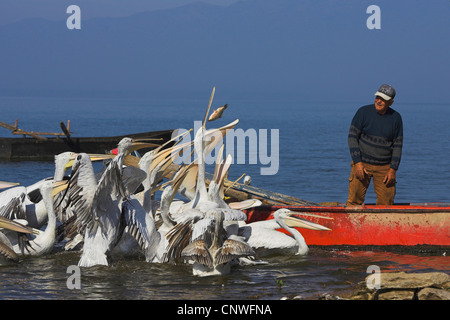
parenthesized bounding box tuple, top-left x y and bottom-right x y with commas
(0, 124, 173, 161)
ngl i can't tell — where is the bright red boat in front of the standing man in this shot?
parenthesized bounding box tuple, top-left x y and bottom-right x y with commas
(247, 204, 450, 246)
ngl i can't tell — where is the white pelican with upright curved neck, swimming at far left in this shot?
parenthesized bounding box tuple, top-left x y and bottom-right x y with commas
(1, 180, 56, 256)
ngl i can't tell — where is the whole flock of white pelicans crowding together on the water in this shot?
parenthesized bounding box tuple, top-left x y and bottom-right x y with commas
(0, 91, 329, 276)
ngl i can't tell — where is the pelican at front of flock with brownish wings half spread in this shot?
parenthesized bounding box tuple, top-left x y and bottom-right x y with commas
(181, 210, 255, 276)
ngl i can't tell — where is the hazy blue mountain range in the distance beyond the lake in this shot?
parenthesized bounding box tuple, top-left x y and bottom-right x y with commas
(0, 0, 450, 102)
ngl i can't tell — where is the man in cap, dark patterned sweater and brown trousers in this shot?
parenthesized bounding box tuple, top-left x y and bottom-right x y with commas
(347, 84, 403, 205)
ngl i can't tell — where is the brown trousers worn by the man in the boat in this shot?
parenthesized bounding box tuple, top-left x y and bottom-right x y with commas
(347, 162, 395, 206)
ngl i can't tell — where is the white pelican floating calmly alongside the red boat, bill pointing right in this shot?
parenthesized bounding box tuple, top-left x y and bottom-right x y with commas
(238, 208, 331, 256)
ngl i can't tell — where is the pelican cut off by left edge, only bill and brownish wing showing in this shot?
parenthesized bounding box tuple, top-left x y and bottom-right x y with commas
(0, 217, 39, 266)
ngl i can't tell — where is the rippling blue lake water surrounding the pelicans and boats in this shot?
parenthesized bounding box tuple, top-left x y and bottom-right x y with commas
(0, 92, 450, 300)
